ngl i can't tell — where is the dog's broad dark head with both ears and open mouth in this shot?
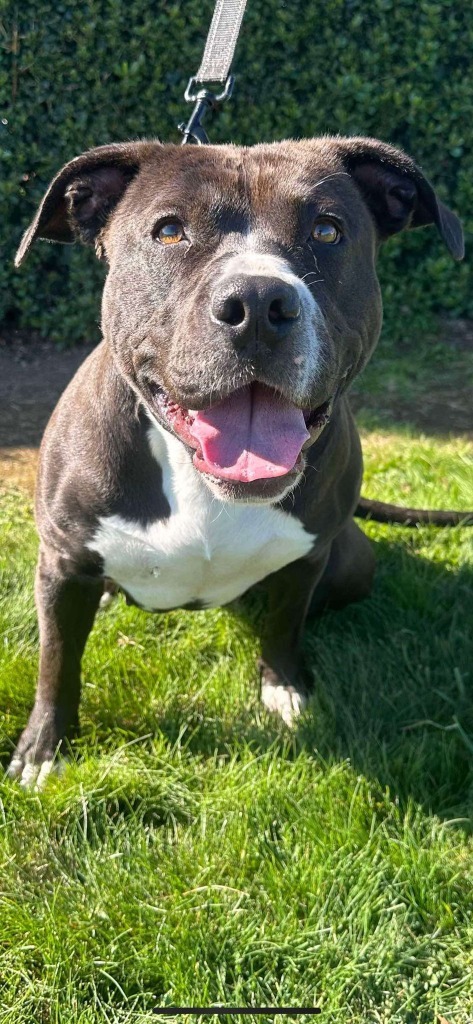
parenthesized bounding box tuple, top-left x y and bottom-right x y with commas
(16, 137, 463, 501)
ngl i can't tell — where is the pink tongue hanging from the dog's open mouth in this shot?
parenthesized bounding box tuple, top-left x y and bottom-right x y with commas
(189, 384, 309, 482)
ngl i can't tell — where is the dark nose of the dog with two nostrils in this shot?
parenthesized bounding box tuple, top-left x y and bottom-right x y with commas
(210, 274, 301, 345)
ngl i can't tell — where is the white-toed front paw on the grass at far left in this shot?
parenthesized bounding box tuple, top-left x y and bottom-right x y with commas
(6, 702, 69, 792)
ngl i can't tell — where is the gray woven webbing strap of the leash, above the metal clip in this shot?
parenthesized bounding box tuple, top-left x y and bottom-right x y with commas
(196, 0, 247, 82)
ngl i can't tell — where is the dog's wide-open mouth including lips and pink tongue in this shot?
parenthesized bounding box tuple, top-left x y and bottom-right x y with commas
(153, 382, 333, 483)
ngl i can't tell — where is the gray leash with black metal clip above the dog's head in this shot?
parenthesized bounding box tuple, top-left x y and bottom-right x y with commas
(179, 0, 247, 145)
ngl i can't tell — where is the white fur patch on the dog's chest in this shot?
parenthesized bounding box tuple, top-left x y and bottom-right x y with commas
(89, 417, 315, 610)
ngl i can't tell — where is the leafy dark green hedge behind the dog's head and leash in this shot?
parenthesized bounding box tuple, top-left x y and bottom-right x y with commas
(0, 0, 473, 344)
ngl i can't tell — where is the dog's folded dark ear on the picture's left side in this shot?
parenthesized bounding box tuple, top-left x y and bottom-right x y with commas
(14, 142, 160, 266)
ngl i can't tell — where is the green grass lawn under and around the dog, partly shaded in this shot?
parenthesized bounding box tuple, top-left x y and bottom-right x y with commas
(0, 429, 473, 1024)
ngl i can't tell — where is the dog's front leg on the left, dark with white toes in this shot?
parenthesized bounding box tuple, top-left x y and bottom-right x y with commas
(8, 549, 103, 786)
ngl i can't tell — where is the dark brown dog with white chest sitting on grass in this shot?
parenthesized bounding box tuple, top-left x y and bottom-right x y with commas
(10, 137, 463, 784)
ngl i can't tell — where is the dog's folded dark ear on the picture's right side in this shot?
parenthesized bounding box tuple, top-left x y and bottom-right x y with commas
(337, 138, 465, 259)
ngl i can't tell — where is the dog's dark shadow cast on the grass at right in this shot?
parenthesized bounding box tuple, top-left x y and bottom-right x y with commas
(149, 535, 473, 828)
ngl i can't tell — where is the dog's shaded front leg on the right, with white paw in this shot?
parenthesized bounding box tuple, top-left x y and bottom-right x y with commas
(260, 548, 330, 726)
